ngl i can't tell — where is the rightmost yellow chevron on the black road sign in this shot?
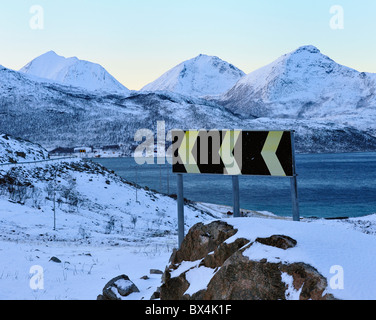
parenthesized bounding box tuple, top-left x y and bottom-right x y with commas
(261, 131, 286, 176)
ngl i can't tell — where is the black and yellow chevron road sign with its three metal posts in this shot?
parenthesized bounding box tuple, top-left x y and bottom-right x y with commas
(172, 130, 300, 246)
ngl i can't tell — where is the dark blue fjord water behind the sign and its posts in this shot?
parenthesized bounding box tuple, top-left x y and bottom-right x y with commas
(94, 153, 376, 218)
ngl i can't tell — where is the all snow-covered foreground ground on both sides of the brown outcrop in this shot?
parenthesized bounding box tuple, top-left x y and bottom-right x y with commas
(0, 160, 376, 300)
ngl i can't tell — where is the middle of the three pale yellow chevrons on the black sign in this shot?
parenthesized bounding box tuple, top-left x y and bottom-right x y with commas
(219, 131, 242, 176)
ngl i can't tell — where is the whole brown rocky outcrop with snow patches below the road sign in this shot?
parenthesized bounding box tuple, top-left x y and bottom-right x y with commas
(160, 221, 334, 300)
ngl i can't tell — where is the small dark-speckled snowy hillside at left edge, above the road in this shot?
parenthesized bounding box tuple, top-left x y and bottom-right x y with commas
(0, 134, 48, 164)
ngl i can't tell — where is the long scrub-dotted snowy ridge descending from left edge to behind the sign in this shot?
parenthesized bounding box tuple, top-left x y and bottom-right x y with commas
(0, 67, 250, 149)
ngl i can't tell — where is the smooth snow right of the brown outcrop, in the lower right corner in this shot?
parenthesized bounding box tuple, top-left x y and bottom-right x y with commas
(227, 215, 376, 300)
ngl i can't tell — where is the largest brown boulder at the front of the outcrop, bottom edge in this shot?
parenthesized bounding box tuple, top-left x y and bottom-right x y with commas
(203, 252, 333, 300)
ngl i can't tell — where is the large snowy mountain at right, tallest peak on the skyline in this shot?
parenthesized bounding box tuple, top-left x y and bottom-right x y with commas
(221, 46, 376, 124)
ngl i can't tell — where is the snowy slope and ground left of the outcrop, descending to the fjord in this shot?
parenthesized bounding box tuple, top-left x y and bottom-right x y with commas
(0, 159, 223, 299)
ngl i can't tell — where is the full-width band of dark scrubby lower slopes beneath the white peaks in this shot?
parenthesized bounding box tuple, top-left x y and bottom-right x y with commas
(0, 50, 376, 155)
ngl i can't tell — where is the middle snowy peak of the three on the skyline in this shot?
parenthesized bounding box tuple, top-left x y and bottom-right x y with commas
(141, 54, 245, 97)
